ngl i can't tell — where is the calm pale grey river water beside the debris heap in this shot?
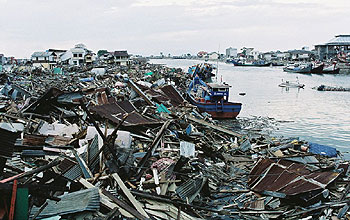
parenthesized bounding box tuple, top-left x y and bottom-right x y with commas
(151, 60, 350, 156)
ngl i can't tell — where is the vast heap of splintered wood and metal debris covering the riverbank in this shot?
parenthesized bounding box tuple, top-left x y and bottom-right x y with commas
(0, 60, 350, 220)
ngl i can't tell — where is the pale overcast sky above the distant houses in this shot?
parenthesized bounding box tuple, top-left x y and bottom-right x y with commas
(0, 0, 350, 58)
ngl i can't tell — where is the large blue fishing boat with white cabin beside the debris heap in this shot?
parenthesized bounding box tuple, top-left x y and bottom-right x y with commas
(187, 76, 242, 119)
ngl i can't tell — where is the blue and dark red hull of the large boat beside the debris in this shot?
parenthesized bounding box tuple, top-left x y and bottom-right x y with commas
(189, 96, 242, 119)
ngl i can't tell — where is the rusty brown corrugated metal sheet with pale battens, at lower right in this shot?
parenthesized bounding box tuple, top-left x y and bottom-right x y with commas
(248, 159, 340, 196)
